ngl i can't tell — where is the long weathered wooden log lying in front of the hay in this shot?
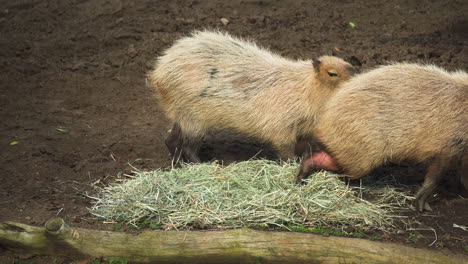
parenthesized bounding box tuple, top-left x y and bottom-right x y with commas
(0, 218, 468, 264)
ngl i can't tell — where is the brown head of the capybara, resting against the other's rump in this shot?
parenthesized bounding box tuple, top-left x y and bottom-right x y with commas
(312, 56, 359, 89)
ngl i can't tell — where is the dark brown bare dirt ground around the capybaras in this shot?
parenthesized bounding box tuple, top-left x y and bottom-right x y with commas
(0, 0, 468, 263)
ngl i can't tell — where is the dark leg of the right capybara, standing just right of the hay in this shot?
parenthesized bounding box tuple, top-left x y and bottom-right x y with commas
(416, 158, 450, 212)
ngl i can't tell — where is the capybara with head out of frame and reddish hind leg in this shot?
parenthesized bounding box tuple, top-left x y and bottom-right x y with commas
(297, 63, 468, 211)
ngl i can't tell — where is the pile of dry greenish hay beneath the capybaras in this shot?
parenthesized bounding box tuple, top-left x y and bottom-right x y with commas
(90, 160, 411, 230)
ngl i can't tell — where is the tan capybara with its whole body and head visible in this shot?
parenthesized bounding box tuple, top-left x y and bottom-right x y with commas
(148, 31, 357, 162)
